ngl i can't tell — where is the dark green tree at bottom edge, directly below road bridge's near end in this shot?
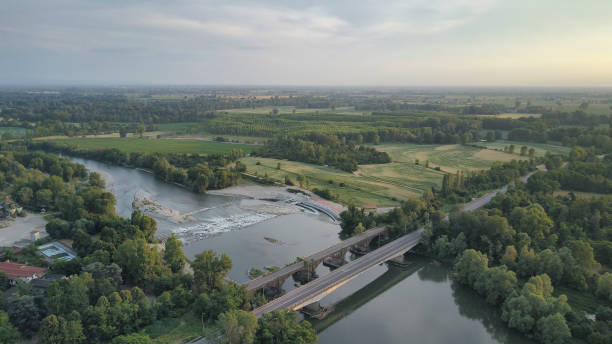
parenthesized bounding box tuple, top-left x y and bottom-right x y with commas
(257, 310, 318, 344)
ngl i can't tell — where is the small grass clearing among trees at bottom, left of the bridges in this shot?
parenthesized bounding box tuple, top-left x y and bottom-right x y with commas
(145, 312, 215, 344)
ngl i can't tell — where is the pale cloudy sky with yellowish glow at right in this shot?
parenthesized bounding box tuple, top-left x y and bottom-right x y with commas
(0, 0, 612, 86)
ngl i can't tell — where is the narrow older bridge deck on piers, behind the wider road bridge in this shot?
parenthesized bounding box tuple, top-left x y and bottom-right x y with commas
(246, 227, 386, 291)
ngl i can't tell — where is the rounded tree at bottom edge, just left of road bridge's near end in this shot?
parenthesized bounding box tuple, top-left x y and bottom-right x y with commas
(213, 310, 257, 344)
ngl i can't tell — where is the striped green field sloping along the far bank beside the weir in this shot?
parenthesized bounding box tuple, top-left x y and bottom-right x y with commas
(240, 157, 420, 207)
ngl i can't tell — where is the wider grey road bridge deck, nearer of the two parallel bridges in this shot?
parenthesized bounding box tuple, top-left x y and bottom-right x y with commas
(253, 229, 423, 317)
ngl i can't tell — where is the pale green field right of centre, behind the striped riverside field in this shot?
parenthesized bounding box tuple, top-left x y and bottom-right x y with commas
(373, 143, 524, 175)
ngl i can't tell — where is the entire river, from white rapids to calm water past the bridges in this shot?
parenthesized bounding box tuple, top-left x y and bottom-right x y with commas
(74, 159, 531, 344)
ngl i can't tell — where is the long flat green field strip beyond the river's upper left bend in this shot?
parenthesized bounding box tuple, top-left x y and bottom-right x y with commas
(45, 137, 255, 154)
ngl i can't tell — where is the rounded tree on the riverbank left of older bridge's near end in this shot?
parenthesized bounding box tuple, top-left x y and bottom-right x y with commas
(191, 250, 232, 290)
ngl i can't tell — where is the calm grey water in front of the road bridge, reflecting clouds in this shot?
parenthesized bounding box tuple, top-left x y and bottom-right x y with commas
(311, 256, 531, 344)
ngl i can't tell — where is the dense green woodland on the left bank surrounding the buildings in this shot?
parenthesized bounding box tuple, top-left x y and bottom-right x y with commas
(0, 152, 316, 343)
